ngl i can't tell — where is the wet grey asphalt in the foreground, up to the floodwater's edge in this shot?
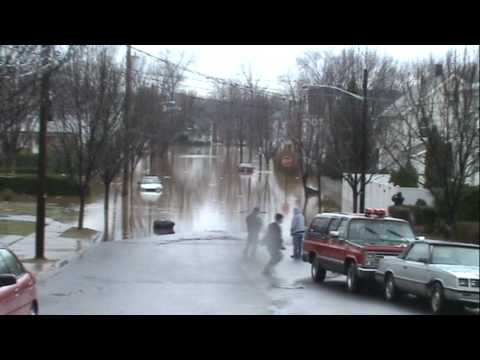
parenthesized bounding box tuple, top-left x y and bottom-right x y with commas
(39, 233, 428, 315)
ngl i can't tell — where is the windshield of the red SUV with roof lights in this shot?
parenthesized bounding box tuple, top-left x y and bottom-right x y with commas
(348, 219, 415, 244)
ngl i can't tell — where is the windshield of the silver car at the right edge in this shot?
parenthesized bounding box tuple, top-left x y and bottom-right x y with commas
(432, 245, 480, 266)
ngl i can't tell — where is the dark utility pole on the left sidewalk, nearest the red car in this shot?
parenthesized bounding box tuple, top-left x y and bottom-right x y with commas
(35, 45, 51, 259)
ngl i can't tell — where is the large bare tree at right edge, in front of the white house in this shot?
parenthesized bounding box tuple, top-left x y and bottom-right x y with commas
(391, 48, 479, 237)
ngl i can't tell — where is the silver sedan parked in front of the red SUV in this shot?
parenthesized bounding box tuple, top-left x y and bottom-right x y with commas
(375, 240, 480, 314)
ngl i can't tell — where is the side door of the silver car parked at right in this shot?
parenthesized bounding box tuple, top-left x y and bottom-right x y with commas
(401, 243, 430, 295)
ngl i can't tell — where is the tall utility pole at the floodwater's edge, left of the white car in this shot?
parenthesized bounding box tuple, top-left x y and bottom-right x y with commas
(122, 45, 132, 239)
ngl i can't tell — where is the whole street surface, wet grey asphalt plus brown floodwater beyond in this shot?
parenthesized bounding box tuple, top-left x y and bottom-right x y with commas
(39, 147, 427, 315)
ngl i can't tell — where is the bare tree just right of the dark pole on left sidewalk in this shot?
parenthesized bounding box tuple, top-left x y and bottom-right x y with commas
(54, 46, 120, 229)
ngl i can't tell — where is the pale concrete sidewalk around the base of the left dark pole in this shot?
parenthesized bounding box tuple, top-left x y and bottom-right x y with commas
(0, 215, 102, 278)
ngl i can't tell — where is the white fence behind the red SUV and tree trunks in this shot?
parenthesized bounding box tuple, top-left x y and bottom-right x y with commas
(342, 174, 433, 212)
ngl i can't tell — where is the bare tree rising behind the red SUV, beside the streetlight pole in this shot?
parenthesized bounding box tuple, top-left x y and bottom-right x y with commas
(297, 48, 398, 211)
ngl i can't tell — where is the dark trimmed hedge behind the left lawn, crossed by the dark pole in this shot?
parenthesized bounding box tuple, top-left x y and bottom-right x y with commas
(0, 174, 78, 196)
